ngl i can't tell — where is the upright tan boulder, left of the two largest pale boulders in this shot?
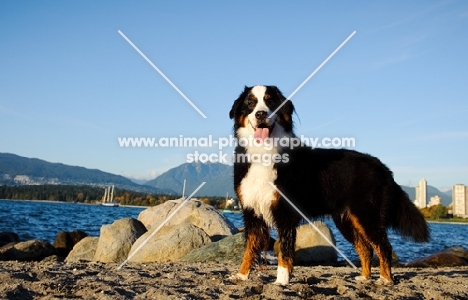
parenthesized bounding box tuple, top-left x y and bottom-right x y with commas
(93, 218, 146, 263)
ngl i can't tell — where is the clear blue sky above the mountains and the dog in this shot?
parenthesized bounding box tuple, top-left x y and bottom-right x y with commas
(0, 1, 468, 190)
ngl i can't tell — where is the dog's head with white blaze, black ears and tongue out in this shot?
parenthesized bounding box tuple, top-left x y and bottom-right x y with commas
(229, 85, 294, 140)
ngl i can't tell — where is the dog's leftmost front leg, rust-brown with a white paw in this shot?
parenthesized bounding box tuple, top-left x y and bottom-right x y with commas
(235, 208, 270, 280)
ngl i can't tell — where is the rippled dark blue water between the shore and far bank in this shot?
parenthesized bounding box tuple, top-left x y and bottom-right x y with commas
(0, 200, 468, 262)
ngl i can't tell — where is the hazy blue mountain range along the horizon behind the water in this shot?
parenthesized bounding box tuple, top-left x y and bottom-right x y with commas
(0, 153, 452, 206)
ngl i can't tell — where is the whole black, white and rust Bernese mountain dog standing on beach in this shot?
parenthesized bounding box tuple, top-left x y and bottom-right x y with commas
(229, 85, 430, 285)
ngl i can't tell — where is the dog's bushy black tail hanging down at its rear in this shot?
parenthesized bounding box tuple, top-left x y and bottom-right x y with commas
(391, 185, 430, 243)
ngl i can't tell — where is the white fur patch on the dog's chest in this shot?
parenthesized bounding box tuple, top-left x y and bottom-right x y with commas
(240, 163, 277, 227)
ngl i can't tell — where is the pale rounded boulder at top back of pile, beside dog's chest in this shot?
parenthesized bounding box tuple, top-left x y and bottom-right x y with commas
(138, 200, 238, 241)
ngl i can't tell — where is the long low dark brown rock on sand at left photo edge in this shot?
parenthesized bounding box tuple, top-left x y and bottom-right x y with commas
(0, 240, 56, 261)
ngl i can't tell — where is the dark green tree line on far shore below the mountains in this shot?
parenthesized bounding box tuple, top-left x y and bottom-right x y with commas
(0, 185, 225, 209)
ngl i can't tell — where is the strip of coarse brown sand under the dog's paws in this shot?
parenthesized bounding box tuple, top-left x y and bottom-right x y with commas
(0, 258, 468, 299)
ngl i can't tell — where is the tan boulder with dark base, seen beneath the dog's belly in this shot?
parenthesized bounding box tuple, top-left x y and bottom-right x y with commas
(274, 221, 337, 266)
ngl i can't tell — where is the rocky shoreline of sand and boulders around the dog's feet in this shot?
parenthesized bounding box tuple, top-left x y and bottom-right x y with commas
(0, 201, 468, 299)
